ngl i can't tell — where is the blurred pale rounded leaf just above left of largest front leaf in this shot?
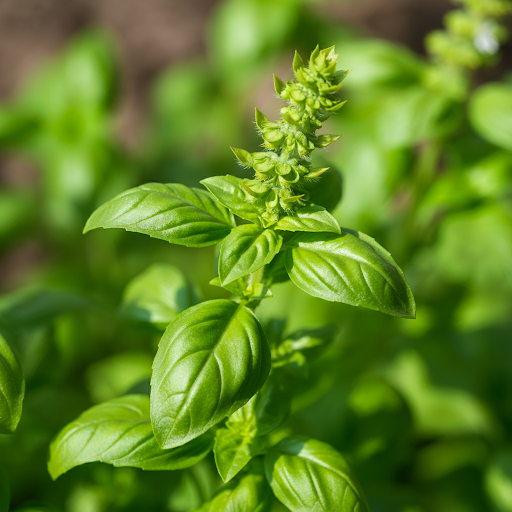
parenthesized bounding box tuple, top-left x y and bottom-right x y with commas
(120, 263, 197, 325)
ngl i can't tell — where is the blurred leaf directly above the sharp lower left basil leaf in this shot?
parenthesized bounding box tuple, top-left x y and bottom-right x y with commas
(85, 351, 153, 403)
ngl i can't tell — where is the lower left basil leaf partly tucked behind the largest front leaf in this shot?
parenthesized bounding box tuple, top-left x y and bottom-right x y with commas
(48, 395, 213, 480)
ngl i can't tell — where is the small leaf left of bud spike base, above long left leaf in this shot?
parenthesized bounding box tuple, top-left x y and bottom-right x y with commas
(201, 174, 260, 224)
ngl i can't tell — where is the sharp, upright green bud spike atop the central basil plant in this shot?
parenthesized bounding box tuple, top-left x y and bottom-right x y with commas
(231, 47, 348, 226)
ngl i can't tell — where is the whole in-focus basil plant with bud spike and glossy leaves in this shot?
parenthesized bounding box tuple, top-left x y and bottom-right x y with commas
(48, 47, 415, 512)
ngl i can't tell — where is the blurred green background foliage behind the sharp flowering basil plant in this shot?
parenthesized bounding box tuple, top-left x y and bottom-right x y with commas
(0, 0, 512, 512)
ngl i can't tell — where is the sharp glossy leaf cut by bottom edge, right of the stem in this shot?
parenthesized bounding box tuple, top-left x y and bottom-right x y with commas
(265, 437, 369, 512)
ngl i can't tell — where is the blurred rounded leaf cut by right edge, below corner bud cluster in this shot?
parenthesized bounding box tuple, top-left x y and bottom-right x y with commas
(469, 83, 512, 151)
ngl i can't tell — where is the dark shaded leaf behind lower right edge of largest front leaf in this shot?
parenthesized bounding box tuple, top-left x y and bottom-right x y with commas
(226, 368, 292, 436)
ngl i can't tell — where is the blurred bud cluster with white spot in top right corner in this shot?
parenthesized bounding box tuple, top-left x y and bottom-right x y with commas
(426, 0, 512, 69)
